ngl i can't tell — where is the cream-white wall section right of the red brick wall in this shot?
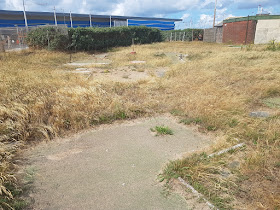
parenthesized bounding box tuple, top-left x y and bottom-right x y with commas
(255, 19, 280, 44)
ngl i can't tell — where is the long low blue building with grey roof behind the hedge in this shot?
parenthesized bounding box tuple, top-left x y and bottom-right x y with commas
(0, 10, 182, 31)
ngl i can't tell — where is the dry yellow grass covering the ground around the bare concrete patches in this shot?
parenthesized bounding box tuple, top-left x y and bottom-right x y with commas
(0, 42, 280, 209)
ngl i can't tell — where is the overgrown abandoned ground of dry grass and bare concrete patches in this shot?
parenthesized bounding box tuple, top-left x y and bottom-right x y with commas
(0, 30, 280, 209)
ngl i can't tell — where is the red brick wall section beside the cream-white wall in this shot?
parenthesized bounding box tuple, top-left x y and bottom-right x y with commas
(223, 20, 257, 44)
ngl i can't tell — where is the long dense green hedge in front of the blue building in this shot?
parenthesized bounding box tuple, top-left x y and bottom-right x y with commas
(27, 26, 163, 51)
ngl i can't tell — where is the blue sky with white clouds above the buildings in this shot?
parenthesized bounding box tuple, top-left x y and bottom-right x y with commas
(0, 0, 280, 29)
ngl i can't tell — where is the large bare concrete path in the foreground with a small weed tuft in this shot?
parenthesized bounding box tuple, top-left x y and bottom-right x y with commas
(26, 116, 210, 210)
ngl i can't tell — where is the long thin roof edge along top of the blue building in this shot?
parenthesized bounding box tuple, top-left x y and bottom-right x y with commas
(0, 10, 183, 22)
